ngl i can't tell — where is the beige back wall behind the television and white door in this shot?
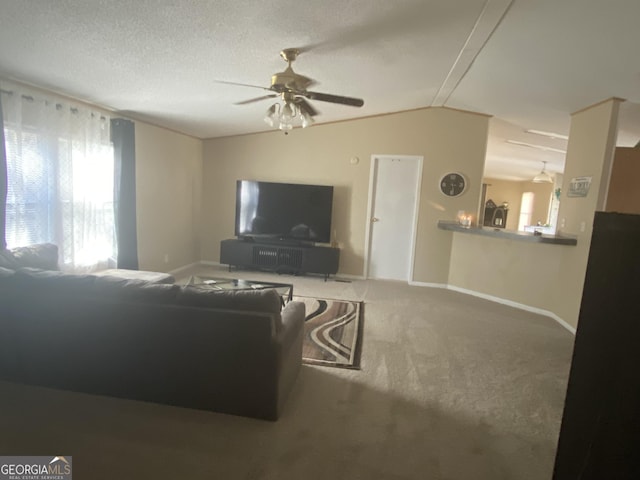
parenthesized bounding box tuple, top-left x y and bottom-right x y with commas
(201, 108, 488, 283)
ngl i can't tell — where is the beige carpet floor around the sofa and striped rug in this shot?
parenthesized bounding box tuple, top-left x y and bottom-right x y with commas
(0, 267, 574, 480)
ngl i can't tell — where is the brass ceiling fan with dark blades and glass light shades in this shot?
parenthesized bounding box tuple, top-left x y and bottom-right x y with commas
(218, 48, 364, 132)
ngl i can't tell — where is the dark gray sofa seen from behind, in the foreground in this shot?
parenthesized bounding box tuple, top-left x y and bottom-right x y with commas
(0, 244, 304, 420)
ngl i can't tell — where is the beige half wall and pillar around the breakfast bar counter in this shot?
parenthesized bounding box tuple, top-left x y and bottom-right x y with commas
(449, 100, 619, 327)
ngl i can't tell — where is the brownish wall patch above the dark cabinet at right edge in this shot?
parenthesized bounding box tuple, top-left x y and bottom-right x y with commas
(607, 147, 640, 213)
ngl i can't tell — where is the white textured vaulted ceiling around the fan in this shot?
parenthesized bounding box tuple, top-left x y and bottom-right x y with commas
(0, 0, 640, 179)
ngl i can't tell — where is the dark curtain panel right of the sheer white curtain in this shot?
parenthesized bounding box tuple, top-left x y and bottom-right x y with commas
(111, 118, 138, 270)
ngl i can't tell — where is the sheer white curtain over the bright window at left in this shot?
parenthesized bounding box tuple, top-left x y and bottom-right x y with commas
(0, 82, 116, 271)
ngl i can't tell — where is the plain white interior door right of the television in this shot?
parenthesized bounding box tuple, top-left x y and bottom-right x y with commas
(367, 155, 422, 281)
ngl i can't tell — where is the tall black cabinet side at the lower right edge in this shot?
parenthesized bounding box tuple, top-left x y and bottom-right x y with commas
(553, 212, 640, 480)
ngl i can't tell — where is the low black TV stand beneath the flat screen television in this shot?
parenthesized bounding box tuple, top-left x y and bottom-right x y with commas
(220, 238, 340, 281)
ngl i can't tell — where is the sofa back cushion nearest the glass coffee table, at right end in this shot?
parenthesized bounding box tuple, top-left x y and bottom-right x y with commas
(177, 285, 282, 314)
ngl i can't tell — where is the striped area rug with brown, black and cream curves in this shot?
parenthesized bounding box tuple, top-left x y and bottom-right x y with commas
(293, 296, 364, 369)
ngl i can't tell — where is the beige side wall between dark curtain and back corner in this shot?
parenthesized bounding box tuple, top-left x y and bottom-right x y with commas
(135, 122, 202, 271)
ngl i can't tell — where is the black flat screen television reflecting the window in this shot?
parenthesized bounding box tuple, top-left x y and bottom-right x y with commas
(235, 180, 333, 243)
